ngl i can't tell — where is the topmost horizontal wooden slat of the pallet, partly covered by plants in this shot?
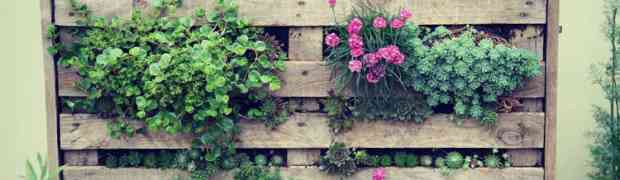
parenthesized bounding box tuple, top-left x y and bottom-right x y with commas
(55, 0, 547, 26)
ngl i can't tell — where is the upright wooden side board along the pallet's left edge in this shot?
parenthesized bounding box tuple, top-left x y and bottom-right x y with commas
(39, 0, 60, 180)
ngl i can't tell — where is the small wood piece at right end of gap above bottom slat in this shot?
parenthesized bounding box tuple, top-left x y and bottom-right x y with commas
(506, 149, 543, 167)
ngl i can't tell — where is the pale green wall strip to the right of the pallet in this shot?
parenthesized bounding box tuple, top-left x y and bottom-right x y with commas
(557, 0, 609, 180)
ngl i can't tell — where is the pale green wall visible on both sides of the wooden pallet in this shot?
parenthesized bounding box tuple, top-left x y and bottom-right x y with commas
(0, 0, 608, 180)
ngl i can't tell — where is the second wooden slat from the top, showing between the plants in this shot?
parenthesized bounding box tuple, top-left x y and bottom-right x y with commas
(58, 61, 545, 98)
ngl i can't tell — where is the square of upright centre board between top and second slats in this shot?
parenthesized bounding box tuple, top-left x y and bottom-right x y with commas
(288, 27, 323, 61)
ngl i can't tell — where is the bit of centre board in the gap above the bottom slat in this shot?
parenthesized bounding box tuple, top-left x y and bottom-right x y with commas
(286, 149, 321, 166)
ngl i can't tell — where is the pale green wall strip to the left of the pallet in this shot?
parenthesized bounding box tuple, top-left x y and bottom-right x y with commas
(0, 0, 46, 180)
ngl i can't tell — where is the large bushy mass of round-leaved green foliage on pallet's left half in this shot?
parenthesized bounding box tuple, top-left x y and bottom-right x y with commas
(50, 0, 288, 179)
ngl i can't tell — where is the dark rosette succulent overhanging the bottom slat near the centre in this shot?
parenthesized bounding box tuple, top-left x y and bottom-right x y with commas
(319, 143, 358, 176)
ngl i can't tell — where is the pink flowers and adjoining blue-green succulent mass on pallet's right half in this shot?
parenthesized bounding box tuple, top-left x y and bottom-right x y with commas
(325, 1, 540, 124)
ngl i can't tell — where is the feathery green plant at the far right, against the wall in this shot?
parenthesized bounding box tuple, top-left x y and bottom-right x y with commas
(589, 0, 620, 180)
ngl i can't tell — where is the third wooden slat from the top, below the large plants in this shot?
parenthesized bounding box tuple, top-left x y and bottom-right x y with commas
(60, 113, 544, 150)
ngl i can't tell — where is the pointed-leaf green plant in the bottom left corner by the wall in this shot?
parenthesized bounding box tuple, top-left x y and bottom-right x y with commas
(23, 153, 64, 180)
